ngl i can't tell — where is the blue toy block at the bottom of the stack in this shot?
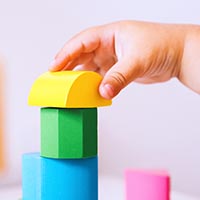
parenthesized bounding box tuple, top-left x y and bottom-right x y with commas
(22, 153, 98, 200)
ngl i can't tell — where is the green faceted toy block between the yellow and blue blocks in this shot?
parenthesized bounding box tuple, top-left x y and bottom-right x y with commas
(41, 108, 97, 158)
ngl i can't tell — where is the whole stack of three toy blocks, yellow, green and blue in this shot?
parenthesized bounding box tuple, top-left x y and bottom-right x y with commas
(22, 71, 111, 200)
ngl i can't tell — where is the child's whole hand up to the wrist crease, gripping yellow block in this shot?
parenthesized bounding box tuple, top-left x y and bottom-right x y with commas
(50, 21, 198, 99)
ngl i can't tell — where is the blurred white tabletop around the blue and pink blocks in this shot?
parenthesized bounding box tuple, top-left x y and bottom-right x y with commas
(0, 177, 200, 200)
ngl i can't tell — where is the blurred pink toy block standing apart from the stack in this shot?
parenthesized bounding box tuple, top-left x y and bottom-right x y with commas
(125, 170, 170, 200)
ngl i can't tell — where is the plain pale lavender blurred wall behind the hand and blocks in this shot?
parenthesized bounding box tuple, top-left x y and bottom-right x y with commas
(0, 0, 200, 197)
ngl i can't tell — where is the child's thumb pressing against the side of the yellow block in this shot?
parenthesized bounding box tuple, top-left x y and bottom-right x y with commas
(99, 59, 140, 99)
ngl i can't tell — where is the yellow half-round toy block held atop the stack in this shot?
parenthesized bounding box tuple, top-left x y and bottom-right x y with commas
(28, 71, 112, 108)
